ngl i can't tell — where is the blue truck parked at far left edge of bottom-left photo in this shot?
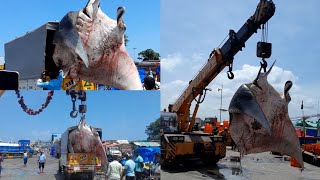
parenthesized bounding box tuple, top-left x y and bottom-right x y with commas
(0, 140, 34, 158)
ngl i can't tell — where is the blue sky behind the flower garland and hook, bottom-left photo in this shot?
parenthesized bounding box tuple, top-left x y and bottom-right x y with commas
(0, 91, 160, 142)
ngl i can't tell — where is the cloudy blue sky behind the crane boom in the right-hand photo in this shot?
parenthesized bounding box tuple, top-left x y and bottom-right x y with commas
(160, 0, 320, 119)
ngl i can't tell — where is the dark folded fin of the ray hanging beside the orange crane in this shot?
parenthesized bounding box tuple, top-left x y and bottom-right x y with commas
(229, 85, 271, 134)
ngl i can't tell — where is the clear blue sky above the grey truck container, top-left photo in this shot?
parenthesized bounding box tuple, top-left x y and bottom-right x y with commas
(0, 0, 160, 63)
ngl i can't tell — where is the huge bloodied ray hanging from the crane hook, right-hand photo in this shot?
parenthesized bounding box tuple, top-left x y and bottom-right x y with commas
(229, 63, 303, 168)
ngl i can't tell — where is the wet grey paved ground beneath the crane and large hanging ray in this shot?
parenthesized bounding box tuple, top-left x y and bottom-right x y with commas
(161, 147, 320, 180)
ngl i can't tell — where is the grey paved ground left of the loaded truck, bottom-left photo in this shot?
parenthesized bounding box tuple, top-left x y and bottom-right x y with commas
(0, 155, 104, 180)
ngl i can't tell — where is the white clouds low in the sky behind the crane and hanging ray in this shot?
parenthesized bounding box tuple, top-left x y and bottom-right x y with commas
(161, 55, 320, 119)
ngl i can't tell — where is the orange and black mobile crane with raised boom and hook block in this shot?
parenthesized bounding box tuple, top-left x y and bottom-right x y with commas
(160, 0, 275, 164)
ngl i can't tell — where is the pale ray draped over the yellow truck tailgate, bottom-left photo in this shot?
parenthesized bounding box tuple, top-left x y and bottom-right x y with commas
(68, 118, 107, 167)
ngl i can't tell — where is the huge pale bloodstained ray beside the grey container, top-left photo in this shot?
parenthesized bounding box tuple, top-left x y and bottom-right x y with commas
(53, 0, 142, 90)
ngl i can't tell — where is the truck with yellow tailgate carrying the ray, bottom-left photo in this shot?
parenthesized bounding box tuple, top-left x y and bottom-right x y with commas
(58, 126, 102, 179)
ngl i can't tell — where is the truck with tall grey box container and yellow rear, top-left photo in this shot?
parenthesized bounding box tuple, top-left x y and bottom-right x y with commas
(2, 22, 98, 90)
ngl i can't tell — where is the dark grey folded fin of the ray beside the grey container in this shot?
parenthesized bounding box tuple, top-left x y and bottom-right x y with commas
(53, 12, 89, 67)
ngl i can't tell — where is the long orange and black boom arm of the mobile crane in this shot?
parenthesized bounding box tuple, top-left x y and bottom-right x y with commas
(168, 0, 275, 131)
